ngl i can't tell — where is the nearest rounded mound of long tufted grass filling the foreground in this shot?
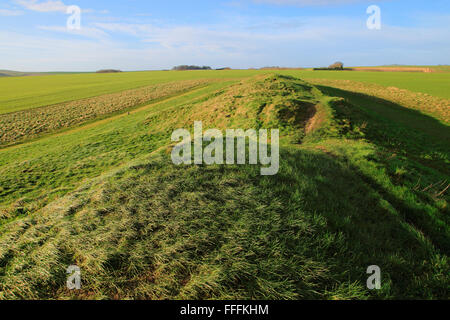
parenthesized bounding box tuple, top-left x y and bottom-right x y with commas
(0, 149, 448, 299)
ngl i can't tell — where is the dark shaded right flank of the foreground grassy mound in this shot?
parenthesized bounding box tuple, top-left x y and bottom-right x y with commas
(272, 151, 450, 298)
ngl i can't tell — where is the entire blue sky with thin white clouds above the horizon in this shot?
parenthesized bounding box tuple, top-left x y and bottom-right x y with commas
(0, 0, 450, 72)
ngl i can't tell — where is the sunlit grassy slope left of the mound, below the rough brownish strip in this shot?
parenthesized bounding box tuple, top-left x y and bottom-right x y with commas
(0, 82, 236, 215)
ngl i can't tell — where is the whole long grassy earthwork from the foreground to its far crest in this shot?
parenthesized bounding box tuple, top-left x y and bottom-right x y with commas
(0, 77, 450, 299)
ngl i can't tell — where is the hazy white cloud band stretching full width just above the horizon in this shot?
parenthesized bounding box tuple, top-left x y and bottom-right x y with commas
(0, 10, 450, 71)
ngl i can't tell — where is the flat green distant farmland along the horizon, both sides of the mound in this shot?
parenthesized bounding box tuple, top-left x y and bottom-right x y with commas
(0, 70, 450, 114)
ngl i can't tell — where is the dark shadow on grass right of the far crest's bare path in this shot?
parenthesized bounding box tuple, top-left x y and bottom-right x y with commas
(318, 86, 450, 176)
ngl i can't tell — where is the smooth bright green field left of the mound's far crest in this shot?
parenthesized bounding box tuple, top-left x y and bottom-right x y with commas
(0, 70, 259, 114)
